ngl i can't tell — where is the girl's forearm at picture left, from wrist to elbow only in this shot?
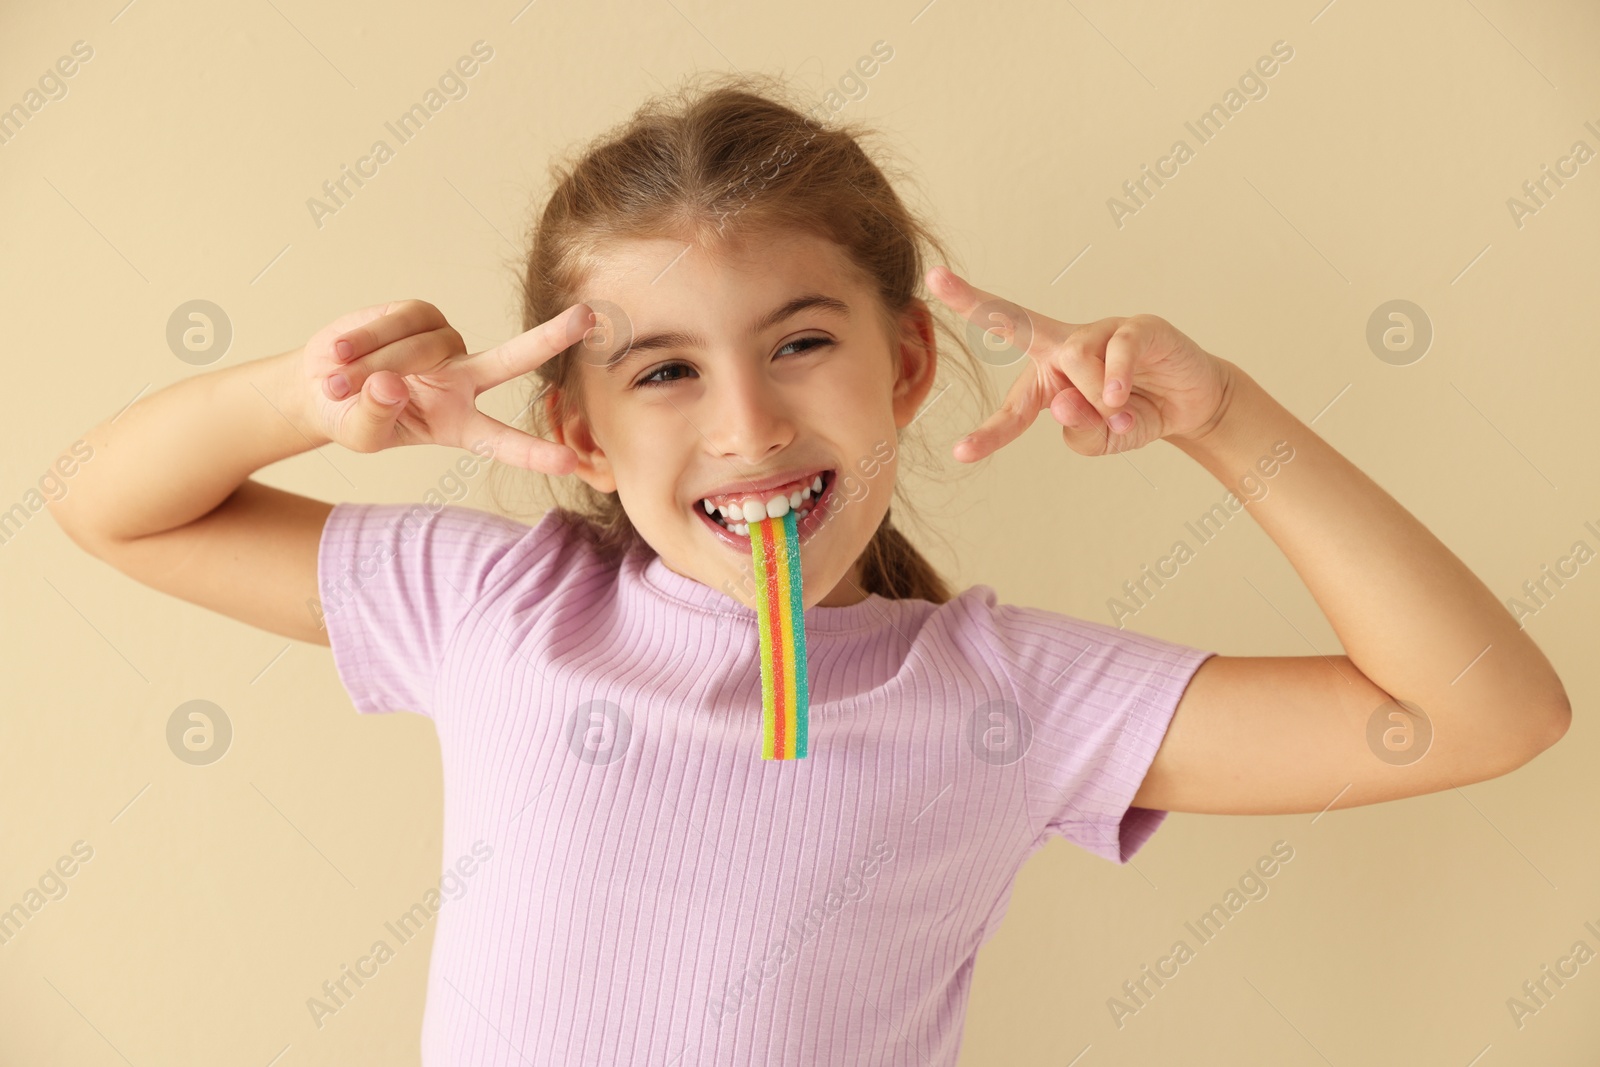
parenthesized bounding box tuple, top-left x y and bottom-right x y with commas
(50, 349, 328, 542)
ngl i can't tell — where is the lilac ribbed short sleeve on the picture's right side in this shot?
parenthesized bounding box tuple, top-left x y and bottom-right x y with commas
(994, 605, 1216, 864)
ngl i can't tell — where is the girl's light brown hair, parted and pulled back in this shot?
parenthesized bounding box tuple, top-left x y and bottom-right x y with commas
(489, 74, 992, 603)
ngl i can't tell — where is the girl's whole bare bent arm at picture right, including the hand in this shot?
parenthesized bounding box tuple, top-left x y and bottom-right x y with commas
(928, 269, 1571, 814)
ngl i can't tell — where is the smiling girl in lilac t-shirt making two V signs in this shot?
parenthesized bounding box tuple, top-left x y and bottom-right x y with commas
(53, 70, 1570, 1067)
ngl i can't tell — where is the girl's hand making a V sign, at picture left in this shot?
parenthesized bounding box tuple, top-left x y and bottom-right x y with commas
(292, 301, 594, 474)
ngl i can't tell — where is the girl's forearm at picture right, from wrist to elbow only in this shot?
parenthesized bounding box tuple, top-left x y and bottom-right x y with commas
(1168, 365, 1568, 741)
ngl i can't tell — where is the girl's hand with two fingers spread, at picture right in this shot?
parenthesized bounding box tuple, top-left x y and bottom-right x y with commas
(926, 267, 1235, 462)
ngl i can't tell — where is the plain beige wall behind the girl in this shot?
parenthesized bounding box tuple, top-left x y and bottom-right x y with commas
(0, 0, 1600, 1067)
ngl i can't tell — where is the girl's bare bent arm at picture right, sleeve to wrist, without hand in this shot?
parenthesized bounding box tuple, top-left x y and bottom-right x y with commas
(1133, 368, 1571, 814)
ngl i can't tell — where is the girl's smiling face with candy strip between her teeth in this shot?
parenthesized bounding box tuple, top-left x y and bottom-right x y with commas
(554, 225, 936, 608)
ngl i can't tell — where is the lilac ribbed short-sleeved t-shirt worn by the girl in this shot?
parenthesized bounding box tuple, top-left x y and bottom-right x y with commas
(317, 504, 1213, 1067)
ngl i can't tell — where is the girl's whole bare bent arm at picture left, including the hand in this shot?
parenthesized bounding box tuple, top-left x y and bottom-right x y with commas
(50, 301, 594, 645)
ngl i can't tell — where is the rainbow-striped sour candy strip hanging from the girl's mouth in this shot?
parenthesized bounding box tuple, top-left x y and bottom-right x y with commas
(750, 510, 810, 760)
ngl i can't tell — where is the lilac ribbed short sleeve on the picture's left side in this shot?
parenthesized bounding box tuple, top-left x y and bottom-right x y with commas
(317, 504, 534, 717)
